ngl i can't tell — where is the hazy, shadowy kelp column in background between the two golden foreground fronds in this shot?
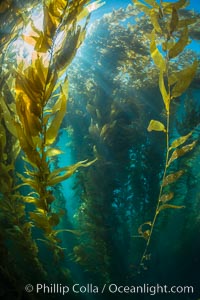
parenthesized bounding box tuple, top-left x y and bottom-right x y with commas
(66, 7, 165, 282)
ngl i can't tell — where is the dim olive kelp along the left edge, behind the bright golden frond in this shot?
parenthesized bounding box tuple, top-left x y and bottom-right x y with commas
(0, 3, 45, 289)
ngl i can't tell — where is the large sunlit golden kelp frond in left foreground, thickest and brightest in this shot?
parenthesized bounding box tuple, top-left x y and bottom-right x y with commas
(11, 0, 101, 260)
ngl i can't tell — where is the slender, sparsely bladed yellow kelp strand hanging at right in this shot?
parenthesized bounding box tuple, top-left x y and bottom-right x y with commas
(133, 0, 198, 270)
